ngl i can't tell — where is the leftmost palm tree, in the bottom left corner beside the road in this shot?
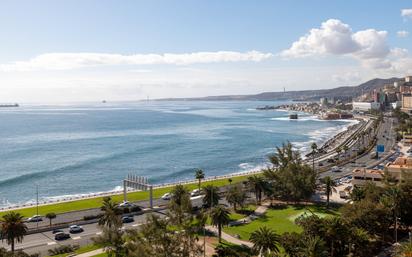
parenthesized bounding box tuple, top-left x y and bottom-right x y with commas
(0, 212, 27, 253)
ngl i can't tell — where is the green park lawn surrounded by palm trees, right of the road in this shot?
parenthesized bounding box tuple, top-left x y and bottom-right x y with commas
(224, 205, 338, 240)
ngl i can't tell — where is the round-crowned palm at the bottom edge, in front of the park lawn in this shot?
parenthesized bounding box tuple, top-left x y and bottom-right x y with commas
(249, 227, 280, 256)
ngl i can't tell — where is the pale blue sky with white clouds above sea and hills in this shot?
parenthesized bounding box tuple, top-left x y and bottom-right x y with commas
(0, 0, 412, 103)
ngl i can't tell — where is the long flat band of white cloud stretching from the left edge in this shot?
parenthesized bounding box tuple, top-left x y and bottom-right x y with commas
(0, 51, 273, 71)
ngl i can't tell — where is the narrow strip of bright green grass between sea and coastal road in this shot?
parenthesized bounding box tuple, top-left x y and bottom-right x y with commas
(0, 175, 248, 217)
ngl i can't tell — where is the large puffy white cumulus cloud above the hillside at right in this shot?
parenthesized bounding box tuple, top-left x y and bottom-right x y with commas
(281, 19, 389, 59)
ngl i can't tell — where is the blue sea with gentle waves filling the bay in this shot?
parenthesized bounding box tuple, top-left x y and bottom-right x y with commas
(0, 101, 351, 206)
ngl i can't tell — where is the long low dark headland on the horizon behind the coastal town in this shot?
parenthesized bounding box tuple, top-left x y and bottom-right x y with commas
(159, 78, 400, 101)
